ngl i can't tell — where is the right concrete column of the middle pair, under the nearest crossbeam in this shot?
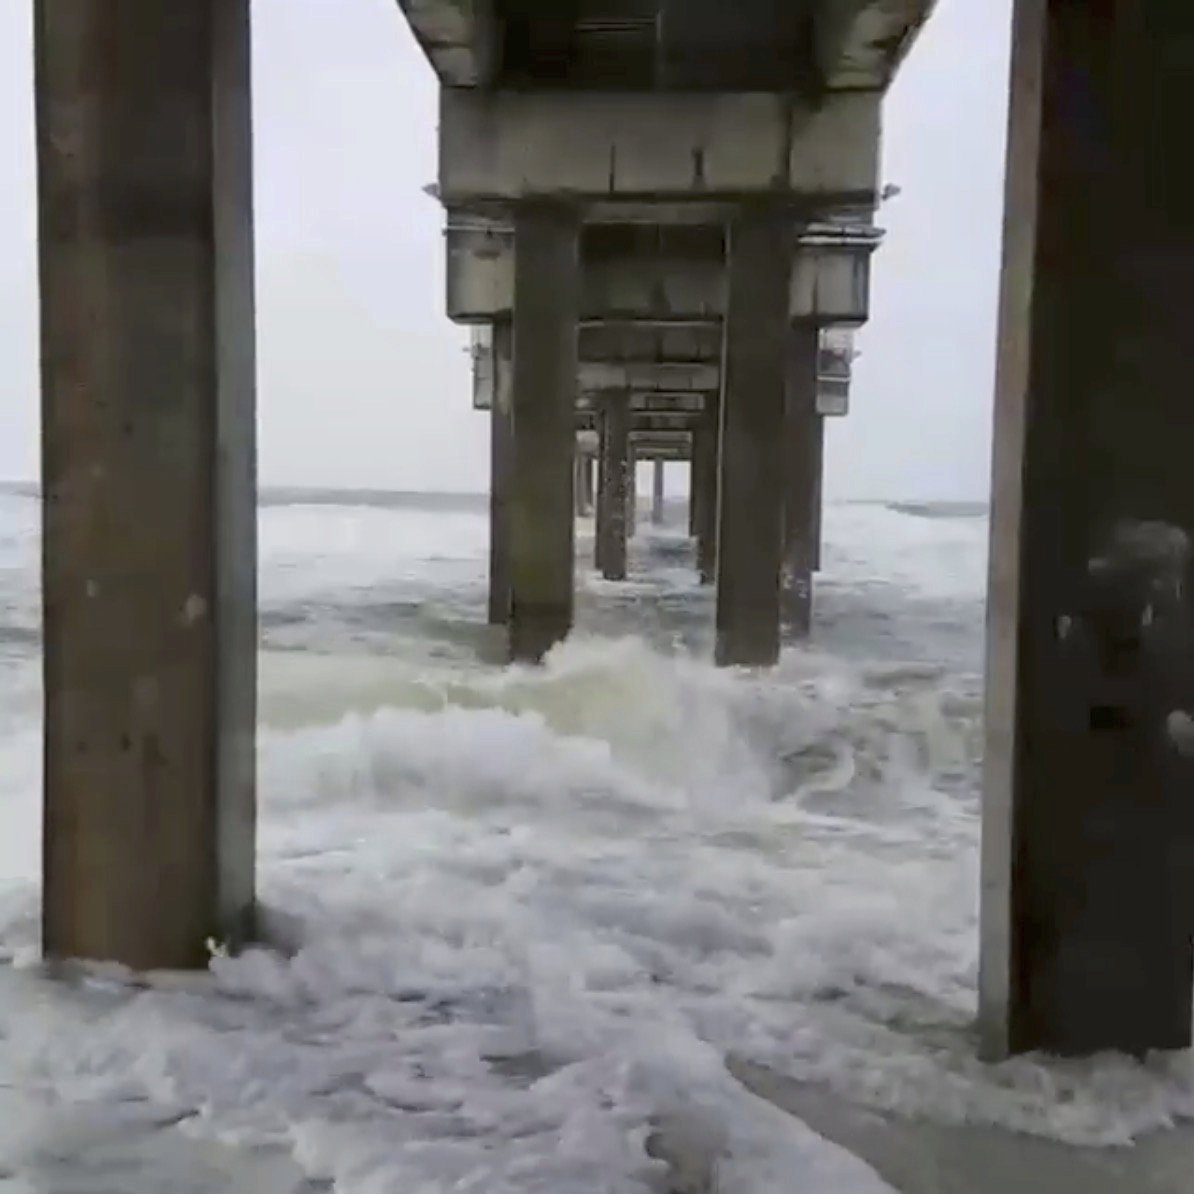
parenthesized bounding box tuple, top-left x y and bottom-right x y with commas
(716, 207, 795, 666)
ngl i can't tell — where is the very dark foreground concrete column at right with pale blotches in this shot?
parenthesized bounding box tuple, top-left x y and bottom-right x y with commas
(979, 0, 1194, 1057)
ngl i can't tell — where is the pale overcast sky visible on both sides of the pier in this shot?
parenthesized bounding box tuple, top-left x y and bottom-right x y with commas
(0, 0, 1010, 498)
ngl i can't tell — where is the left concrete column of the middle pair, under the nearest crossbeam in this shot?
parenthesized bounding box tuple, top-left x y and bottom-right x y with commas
(510, 202, 580, 663)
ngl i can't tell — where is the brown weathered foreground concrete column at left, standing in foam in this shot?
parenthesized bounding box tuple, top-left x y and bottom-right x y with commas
(33, 0, 257, 970)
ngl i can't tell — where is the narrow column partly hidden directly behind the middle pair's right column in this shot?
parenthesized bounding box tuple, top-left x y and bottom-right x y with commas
(781, 324, 821, 639)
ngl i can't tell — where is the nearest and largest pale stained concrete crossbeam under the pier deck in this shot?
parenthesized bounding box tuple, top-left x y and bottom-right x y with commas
(439, 87, 881, 208)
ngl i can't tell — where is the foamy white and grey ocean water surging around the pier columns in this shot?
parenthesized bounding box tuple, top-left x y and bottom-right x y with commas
(0, 493, 1194, 1194)
